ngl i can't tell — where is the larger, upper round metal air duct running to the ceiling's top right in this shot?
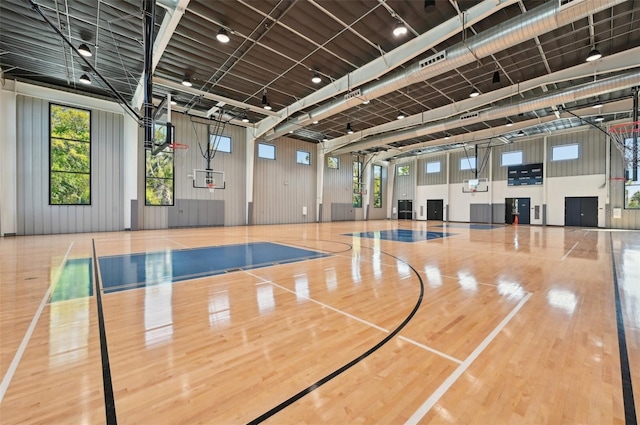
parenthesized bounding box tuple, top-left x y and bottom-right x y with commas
(267, 0, 625, 140)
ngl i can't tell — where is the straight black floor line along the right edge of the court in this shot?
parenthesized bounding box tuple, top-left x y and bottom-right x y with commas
(609, 232, 638, 425)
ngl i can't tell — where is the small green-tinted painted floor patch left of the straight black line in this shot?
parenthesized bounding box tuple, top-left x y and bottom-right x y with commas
(49, 258, 93, 303)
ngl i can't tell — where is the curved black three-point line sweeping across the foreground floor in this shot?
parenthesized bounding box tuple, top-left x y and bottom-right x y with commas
(248, 251, 424, 425)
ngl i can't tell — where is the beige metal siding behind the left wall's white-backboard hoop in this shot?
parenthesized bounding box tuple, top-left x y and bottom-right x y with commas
(142, 113, 246, 229)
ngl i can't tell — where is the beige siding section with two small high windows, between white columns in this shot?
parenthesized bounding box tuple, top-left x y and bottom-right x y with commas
(253, 137, 318, 224)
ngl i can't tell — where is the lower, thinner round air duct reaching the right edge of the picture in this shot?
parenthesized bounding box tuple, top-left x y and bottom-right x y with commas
(332, 70, 640, 155)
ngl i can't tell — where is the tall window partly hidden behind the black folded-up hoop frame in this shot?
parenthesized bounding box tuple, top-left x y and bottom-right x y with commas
(145, 124, 174, 206)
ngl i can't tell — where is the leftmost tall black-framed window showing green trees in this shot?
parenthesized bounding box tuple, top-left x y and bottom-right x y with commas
(49, 104, 91, 205)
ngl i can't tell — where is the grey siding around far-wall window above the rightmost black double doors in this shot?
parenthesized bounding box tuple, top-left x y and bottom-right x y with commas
(545, 129, 607, 177)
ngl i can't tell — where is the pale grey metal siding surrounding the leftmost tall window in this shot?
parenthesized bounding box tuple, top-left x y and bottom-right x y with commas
(17, 96, 124, 235)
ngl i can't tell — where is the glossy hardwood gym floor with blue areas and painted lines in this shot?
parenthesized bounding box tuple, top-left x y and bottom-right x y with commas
(0, 221, 640, 425)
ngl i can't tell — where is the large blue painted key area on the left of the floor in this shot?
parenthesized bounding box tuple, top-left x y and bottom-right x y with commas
(99, 242, 329, 293)
